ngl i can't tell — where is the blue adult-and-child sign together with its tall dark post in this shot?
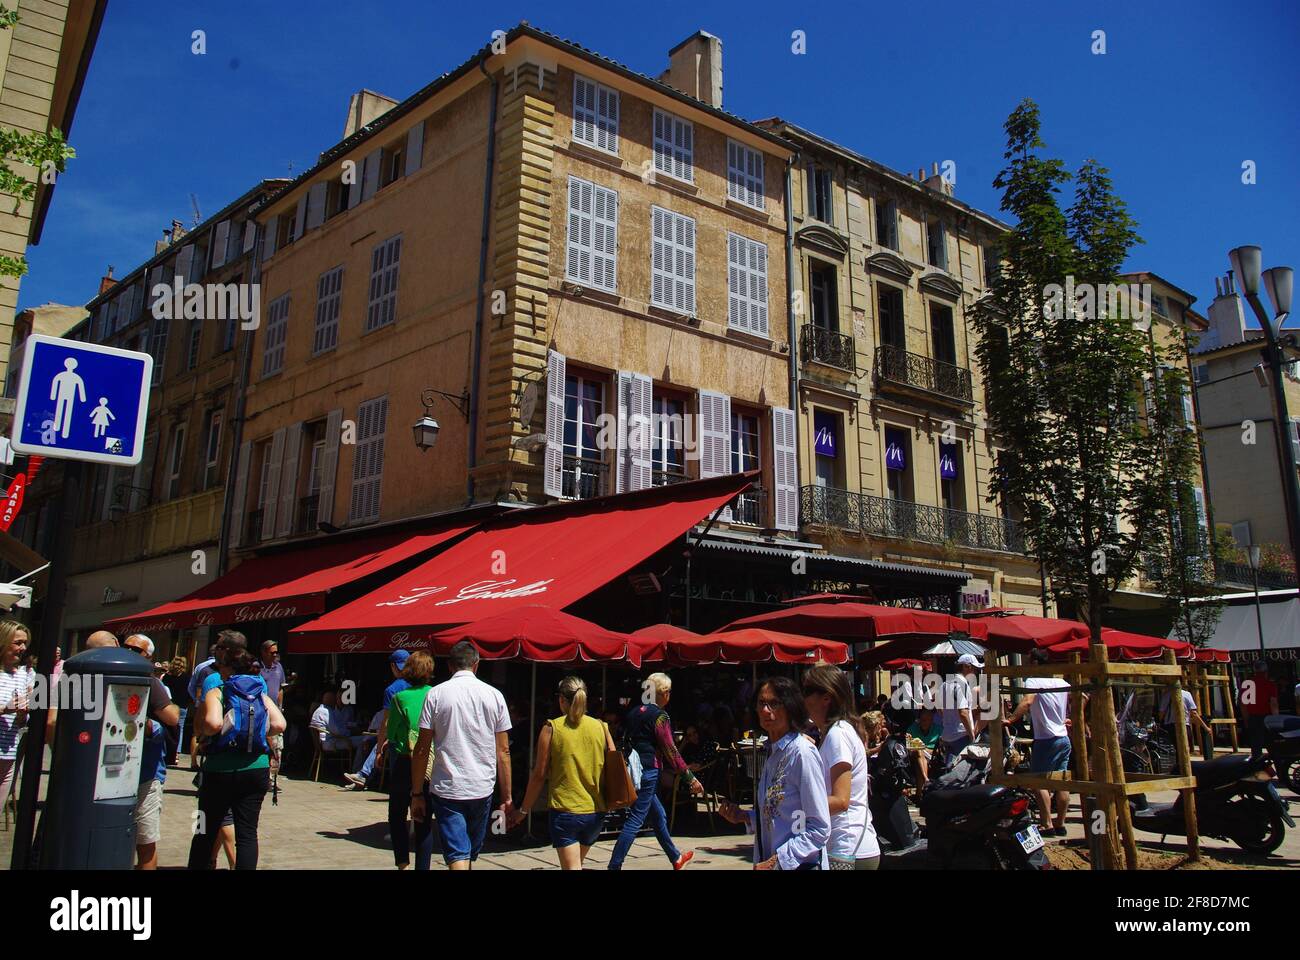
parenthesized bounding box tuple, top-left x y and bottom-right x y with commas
(10, 333, 153, 870)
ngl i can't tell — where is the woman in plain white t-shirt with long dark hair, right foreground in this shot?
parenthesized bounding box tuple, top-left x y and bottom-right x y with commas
(803, 666, 880, 870)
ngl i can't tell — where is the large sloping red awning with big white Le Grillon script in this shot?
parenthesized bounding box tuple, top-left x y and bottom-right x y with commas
(289, 472, 757, 652)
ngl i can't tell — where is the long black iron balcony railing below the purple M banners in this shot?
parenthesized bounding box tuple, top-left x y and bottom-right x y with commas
(800, 487, 1024, 553)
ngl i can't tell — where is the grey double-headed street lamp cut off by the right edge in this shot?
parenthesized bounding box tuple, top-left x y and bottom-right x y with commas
(1229, 246, 1300, 581)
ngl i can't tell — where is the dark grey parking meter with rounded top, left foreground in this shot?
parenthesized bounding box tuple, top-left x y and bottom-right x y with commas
(40, 647, 152, 870)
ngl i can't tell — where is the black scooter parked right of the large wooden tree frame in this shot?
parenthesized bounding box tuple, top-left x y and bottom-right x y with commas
(1130, 753, 1295, 855)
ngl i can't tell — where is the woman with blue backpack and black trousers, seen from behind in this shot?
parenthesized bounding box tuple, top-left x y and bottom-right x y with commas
(190, 630, 286, 870)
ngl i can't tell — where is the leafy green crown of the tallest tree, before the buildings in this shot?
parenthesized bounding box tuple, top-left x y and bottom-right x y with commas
(974, 100, 1190, 643)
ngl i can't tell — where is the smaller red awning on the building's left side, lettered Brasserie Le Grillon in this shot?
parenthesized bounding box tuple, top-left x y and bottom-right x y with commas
(104, 523, 475, 633)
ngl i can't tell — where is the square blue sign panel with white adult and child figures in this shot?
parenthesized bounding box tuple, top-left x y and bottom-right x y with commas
(13, 333, 153, 467)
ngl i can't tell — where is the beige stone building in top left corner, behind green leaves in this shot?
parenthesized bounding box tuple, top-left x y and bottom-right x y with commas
(0, 0, 108, 379)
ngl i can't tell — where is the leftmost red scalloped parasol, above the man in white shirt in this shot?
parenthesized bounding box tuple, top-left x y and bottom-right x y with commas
(421, 604, 641, 666)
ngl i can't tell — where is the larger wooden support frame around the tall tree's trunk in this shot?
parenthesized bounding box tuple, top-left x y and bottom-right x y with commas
(987, 644, 1201, 870)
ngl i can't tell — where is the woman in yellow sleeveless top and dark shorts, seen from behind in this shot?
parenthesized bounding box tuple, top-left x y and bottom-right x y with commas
(510, 676, 614, 870)
